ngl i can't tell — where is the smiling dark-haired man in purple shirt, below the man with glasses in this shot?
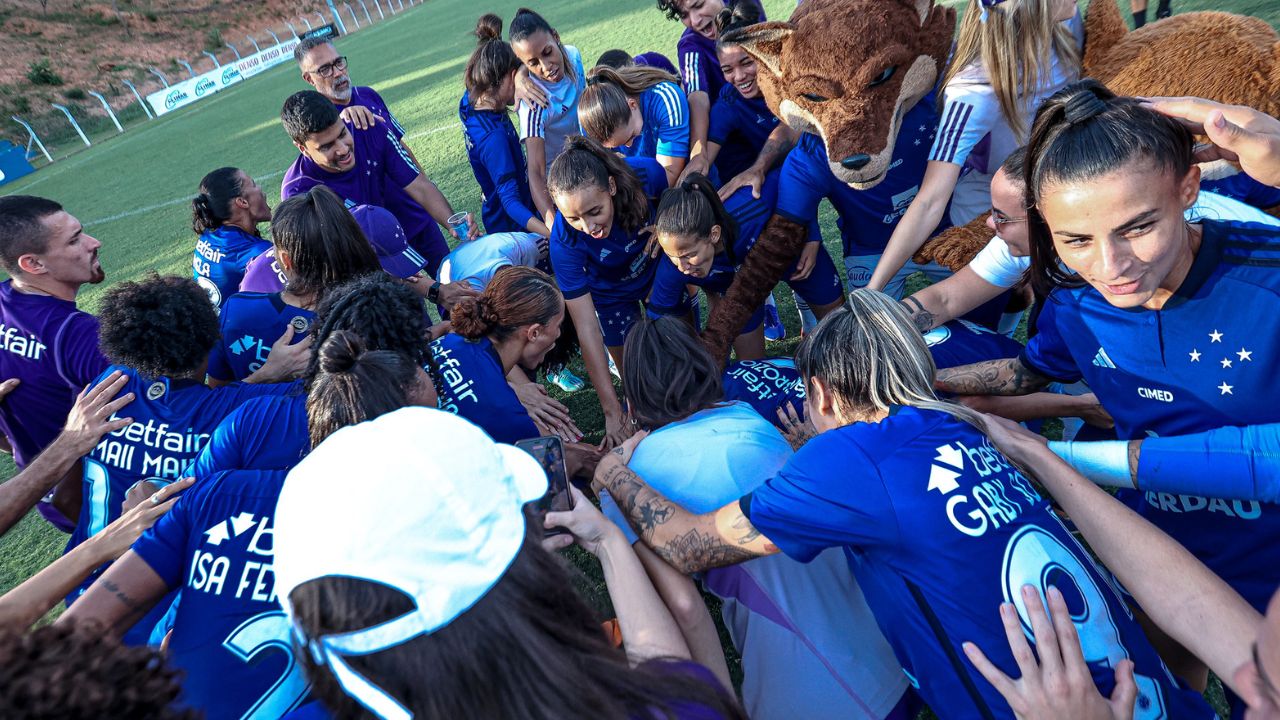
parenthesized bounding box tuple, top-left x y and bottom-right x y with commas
(280, 90, 480, 307)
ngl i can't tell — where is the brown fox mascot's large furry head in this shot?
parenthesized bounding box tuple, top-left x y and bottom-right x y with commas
(724, 0, 955, 190)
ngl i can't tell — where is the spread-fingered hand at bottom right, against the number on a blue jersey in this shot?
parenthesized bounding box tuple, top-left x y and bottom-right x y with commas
(964, 585, 1138, 720)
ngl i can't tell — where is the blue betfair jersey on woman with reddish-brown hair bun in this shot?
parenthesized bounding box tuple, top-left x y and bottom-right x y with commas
(431, 333, 541, 443)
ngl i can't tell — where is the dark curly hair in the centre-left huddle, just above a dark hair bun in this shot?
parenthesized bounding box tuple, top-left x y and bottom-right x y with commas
(307, 272, 431, 378)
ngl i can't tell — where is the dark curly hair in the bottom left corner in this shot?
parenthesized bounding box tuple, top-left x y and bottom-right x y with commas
(0, 625, 200, 720)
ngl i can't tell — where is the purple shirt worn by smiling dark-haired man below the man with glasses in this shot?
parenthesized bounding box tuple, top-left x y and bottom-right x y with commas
(280, 124, 449, 267)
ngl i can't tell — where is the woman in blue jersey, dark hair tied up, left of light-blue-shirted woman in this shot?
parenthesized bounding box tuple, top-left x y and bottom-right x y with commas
(458, 13, 550, 237)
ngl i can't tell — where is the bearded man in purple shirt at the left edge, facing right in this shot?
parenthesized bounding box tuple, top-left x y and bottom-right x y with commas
(0, 195, 108, 529)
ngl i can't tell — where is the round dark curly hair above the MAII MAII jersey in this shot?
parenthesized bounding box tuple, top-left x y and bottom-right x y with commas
(99, 272, 221, 378)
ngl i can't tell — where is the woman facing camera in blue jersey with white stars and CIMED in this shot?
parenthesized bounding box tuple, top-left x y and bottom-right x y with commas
(938, 81, 1280, 696)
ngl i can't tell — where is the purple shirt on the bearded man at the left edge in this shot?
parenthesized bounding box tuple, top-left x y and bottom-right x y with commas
(0, 281, 108, 468)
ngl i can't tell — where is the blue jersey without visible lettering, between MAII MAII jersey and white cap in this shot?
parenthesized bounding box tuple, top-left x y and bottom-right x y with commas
(183, 386, 311, 480)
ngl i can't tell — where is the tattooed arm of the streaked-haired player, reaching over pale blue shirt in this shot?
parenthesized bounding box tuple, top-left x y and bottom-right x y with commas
(593, 452, 778, 573)
